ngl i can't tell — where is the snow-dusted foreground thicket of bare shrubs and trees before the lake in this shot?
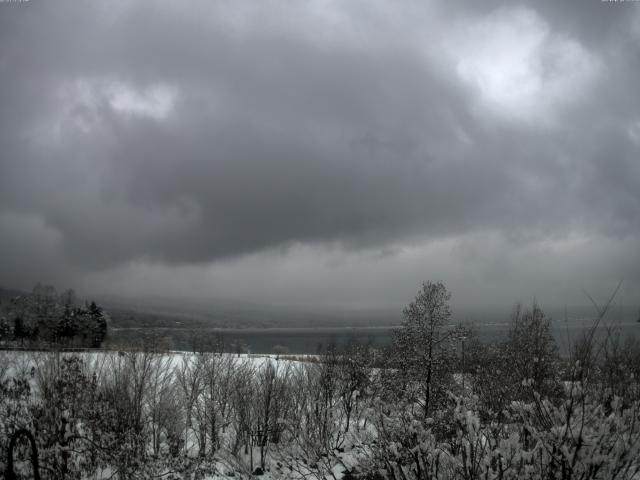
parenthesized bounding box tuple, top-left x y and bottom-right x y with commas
(0, 283, 640, 480)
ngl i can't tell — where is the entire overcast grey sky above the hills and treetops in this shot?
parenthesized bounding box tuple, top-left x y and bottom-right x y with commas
(0, 0, 640, 309)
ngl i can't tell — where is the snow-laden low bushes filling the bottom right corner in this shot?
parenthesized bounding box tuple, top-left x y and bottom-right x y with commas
(368, 390, 640, 480)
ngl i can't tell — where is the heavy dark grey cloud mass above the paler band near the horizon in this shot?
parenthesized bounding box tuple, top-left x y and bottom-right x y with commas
(0, 1, 640, 308)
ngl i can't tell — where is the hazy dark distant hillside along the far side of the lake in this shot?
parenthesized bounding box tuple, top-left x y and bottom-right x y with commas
(0, 287, 638, 329)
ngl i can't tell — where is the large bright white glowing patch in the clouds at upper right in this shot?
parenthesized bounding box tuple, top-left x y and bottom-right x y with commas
(448, 8, 595, 119)
